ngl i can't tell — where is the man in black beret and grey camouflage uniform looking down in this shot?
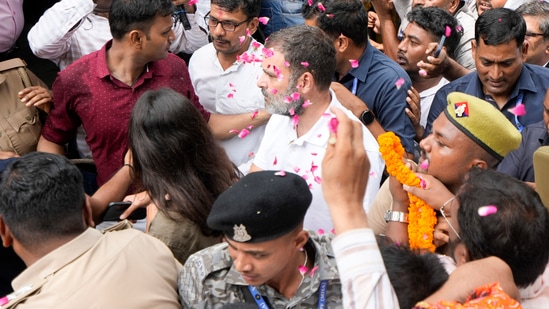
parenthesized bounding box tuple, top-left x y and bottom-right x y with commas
(179, 171, 342, 308)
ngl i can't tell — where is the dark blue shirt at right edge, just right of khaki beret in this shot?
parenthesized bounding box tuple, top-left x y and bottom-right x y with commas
(497, 121, 549, 182)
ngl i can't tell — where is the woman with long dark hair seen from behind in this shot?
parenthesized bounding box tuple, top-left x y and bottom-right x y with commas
(129, 89, 238, 263)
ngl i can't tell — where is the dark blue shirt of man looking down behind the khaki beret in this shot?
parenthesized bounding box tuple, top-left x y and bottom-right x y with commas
(424, 63, 549, 136)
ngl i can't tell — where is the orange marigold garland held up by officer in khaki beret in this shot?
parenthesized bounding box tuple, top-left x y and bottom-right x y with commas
(377, 132, 437, 252)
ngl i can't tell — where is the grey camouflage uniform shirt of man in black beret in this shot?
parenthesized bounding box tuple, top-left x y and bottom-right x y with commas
(178, 232, 343, 308)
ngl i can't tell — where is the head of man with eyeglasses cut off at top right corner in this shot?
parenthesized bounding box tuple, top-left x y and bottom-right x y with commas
(516, 1, 549, 68)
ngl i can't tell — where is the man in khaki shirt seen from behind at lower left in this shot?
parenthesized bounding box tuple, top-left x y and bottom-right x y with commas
(0, 152, 181, 309)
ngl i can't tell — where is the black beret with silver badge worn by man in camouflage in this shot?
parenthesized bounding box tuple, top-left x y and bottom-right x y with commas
(208, 171, 312, 243)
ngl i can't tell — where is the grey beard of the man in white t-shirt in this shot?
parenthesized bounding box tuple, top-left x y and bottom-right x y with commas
(261, 80, 305, 116)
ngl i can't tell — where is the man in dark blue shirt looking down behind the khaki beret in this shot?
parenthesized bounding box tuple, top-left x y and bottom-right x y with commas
(425, 8, 549, 135)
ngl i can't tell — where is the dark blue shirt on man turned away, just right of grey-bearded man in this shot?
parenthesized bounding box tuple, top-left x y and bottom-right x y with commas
(335, 43, 416, 153)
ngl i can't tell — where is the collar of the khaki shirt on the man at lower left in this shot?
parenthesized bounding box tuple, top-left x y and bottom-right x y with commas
(12, 228, 103, 291)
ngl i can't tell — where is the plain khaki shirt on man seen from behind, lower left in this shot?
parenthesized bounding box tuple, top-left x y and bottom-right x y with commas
(1, 228, 181, 309)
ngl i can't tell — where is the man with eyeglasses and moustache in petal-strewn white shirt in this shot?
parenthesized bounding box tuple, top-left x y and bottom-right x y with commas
(189, 0, 270, 174)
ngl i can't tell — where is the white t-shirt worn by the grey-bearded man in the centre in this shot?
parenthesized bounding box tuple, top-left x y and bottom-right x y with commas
(254, 90, 385, 232)
